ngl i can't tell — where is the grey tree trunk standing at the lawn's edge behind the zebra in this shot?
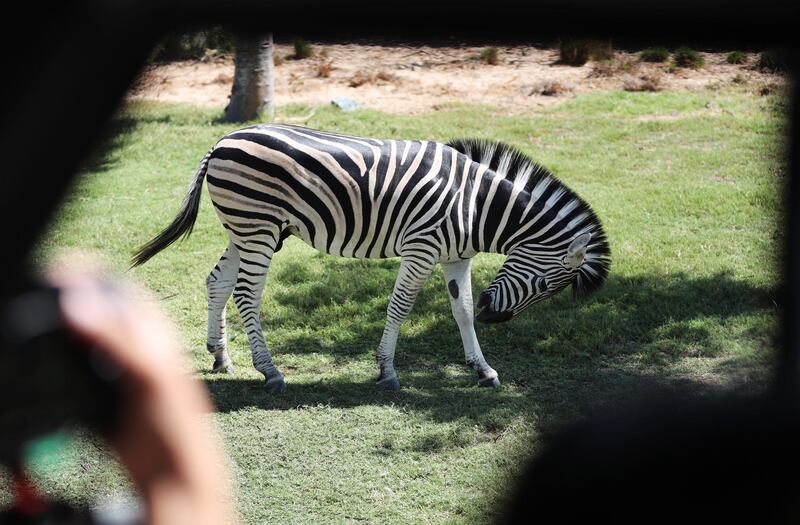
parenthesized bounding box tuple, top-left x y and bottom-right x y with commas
(225, 33, 275, 122)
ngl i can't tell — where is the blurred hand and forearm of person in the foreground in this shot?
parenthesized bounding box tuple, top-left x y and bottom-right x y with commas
(48, 264, 234, 525)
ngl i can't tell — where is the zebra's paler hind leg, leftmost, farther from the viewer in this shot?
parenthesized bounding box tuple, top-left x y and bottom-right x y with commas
(206, 243, 239, 374)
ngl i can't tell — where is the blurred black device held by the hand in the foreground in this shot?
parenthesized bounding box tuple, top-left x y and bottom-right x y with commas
(0, 285, 122, 465)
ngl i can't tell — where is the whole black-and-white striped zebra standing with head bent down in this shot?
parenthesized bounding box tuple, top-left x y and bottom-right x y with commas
(132, 124, 611, 392)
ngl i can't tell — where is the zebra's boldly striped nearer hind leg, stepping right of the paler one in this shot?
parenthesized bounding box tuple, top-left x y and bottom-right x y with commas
(233, 232, 286, 392)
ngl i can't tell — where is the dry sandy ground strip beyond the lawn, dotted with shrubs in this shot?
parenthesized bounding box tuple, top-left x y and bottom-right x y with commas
(129, 44, 785, 114)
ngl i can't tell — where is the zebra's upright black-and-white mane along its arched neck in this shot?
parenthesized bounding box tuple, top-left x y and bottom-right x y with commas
(447, 138, 611, 299)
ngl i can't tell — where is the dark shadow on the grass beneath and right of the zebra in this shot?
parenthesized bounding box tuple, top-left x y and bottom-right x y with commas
(206, 257, 778, 426)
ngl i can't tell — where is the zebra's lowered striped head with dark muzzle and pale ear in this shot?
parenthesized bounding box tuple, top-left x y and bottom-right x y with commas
(475, 230, 609, 323)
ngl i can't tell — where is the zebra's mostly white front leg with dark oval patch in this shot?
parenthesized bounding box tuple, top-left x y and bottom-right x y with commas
(442, 259, 500, 387)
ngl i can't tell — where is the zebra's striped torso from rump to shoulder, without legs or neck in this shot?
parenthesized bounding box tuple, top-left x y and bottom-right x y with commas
(207, 125, 472, 258)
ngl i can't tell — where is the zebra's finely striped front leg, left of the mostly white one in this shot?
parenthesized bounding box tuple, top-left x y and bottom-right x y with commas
(375, 257, 435, 390)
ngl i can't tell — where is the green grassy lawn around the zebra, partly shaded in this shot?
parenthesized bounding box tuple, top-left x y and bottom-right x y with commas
(9, 90, 784, 523)
